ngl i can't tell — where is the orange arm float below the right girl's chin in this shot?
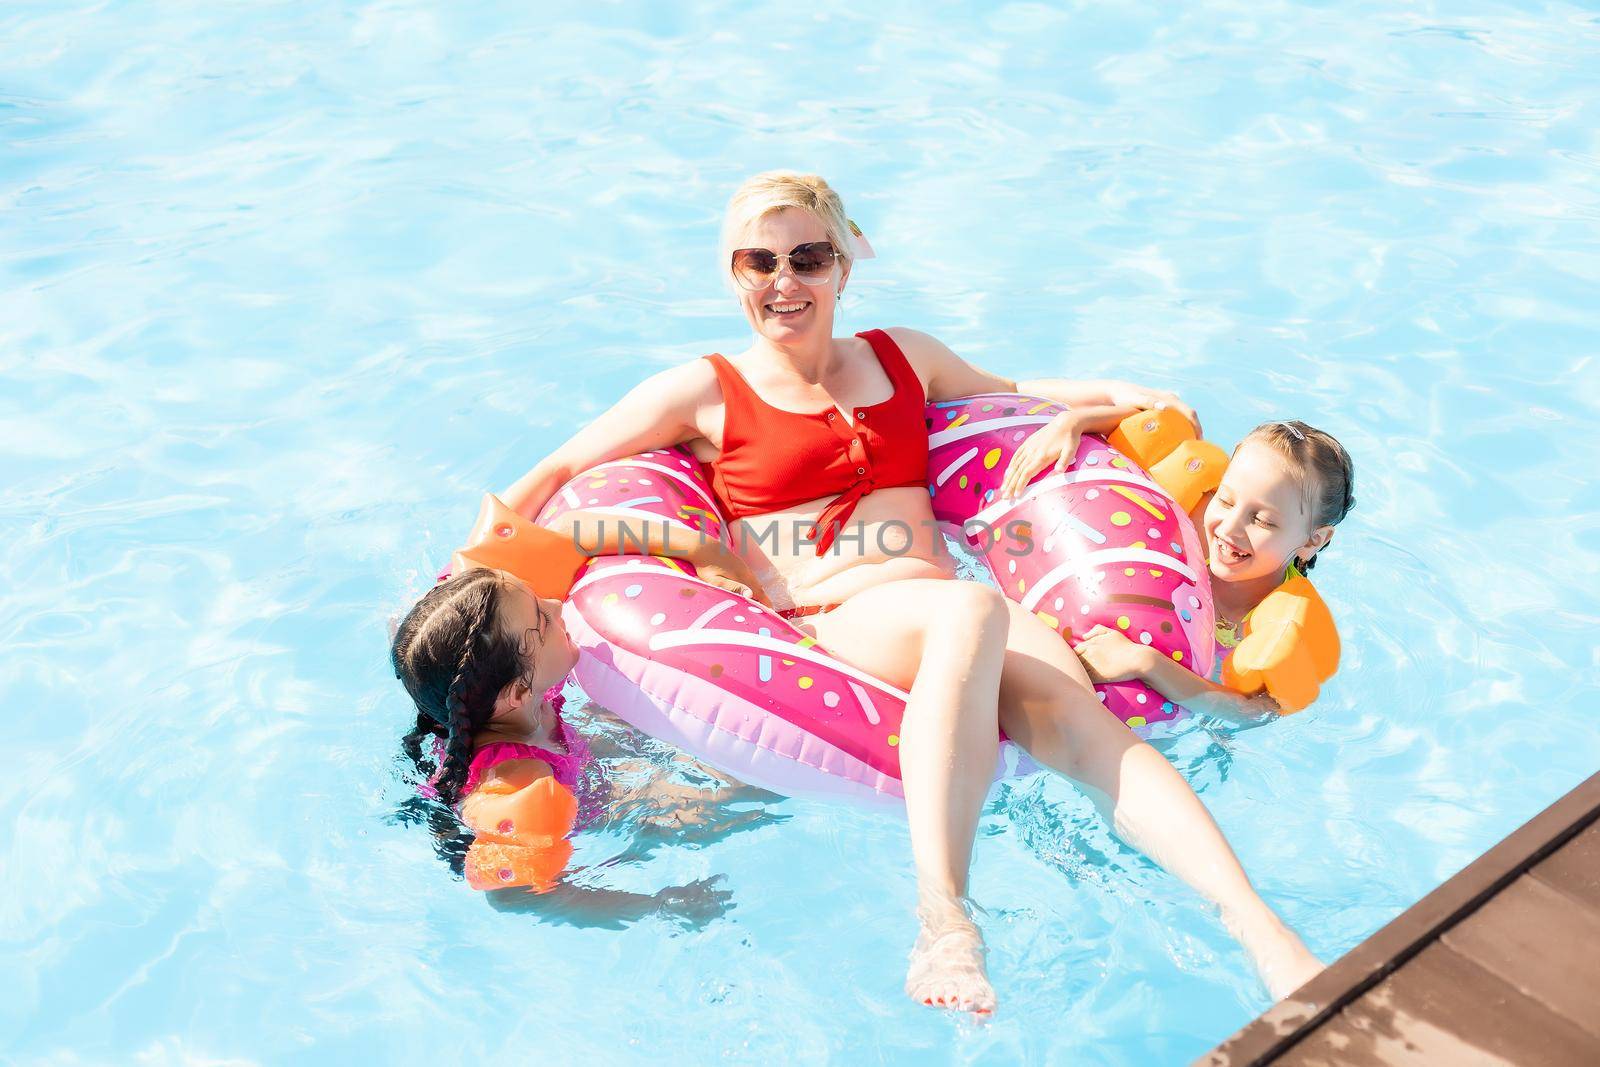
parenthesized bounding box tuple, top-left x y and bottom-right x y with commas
(1222, 574, 1339, 715)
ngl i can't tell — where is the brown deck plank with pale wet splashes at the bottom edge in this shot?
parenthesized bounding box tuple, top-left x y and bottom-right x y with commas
(1277, 944, 1600, 1067)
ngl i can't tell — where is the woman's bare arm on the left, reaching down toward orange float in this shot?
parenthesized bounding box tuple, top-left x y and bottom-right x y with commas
(501, 360, 717, 518)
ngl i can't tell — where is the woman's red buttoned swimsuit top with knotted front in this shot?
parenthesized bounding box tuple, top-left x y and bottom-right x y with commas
(706, 330, 928, 555)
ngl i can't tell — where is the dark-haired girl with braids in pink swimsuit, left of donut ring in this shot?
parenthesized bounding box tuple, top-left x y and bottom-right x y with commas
(390, 514, 766, 891)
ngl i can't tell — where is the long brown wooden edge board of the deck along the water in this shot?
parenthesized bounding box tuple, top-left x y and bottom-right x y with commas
(1195, 774, 1600, 1067)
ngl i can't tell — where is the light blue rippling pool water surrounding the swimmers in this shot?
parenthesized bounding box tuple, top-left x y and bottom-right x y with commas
(0, 0, 1600, 1064)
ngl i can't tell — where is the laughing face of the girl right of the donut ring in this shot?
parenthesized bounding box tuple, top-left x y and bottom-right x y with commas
(1205, 442, 1333, 582)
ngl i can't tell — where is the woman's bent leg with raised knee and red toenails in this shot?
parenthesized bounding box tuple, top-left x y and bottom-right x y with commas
(813, 579, 1008, 1011)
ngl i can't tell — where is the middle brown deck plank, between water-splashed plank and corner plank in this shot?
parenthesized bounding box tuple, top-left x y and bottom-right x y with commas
(1442, 875, 1600, 1041)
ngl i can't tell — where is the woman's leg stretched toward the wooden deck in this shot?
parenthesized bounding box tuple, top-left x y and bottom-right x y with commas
(1000, 601, 1322, 997)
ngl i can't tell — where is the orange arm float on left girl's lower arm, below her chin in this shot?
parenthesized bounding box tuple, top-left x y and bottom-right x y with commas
(461, 777, 578, 893)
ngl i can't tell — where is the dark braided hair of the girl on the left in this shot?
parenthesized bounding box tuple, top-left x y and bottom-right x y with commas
(390, 569, 533, 806)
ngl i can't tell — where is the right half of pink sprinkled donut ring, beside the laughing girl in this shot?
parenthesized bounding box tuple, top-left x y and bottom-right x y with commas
(926, 394, 1216, 734)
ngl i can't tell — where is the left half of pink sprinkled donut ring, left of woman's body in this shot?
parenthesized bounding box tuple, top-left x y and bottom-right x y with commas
(538, 448, 1037, 806)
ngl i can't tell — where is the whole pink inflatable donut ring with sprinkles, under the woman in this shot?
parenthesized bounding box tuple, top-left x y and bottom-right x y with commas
(538, 395, 1214, 805)
